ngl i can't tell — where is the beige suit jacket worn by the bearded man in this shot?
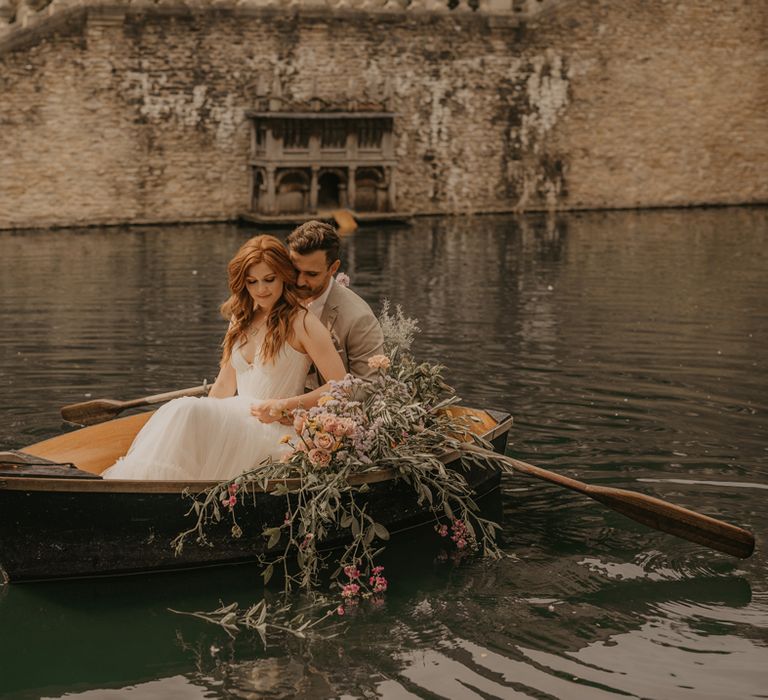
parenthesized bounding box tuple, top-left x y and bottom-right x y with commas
(307, 282, 384, 389)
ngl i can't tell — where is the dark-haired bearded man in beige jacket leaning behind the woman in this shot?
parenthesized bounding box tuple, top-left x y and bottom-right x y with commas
(285, 221, 384, 389)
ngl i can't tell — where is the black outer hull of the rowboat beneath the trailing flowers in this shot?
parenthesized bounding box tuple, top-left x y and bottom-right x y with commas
(0, 414, 511, 582)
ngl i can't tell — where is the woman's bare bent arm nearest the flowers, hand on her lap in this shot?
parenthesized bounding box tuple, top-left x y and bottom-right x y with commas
(251, 313, 347, 423)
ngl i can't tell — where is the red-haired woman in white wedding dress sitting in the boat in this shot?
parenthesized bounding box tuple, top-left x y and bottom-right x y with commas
(102, 236, 346, 481)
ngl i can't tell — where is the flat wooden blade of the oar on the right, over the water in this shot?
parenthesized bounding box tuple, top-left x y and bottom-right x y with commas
(585, 486, 755, 559)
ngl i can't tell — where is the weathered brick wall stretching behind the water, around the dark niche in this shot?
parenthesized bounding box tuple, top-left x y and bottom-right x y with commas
(0, 0, 768, 228)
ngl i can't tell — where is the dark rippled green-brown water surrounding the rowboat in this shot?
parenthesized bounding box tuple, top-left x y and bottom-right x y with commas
(0, 209, 768, 700)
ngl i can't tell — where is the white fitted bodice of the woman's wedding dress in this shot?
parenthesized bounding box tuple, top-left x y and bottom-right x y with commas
(231, 343, 311, 399)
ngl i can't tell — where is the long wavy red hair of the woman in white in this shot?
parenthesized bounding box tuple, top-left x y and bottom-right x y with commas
(221, 236, 303, 366)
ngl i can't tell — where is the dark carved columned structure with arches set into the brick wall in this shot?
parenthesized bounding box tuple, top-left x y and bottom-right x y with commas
(248, 111, 396, 218)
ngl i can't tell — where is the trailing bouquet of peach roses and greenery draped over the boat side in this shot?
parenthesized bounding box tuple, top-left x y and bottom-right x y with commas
(174, 302, 501, 615)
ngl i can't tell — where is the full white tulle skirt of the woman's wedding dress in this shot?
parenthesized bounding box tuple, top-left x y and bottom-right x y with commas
(102, 396, 295, 481)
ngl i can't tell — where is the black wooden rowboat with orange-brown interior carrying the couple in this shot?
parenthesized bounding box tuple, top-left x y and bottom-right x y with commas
(0, 409, 512, 581)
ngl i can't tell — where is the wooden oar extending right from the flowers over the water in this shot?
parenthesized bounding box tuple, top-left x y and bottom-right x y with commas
(462, 445, 755, 559)
